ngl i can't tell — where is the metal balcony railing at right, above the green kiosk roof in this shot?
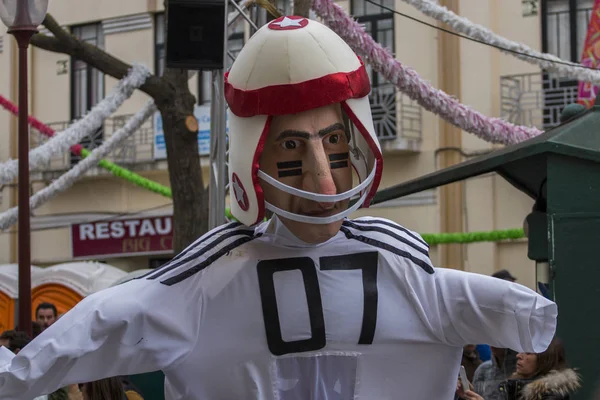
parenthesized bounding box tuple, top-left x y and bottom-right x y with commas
(500, 73, 578, 129)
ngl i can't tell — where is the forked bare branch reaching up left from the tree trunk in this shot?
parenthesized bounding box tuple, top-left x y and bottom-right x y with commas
(32, 14, 175, 105)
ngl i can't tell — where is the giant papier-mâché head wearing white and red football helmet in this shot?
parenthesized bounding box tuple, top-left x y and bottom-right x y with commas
(225, 17, 383, 242)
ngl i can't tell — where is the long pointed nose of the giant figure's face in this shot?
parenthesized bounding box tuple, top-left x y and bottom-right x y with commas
(302, 146, 337, 209)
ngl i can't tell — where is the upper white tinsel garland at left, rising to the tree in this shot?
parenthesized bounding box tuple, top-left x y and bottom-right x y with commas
(0, 64, 150, 184)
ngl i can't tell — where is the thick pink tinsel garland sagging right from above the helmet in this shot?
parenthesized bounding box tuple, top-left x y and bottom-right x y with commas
(313, 0, 543, 144)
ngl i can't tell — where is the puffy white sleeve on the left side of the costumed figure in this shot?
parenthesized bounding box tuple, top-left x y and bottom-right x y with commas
(0, 279, 201, 399)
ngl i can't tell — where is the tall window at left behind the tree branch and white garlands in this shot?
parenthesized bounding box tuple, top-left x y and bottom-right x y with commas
(71, 23, 104, 163)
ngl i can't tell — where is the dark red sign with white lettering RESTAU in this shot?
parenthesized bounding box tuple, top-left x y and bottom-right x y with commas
(71, 216, 173, 258)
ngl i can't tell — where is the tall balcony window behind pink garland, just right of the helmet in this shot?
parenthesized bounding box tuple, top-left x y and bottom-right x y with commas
(351, 0, 397, 140)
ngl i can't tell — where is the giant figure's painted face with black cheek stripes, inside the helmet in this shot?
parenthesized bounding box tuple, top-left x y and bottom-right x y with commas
(259, 104, 352, 243)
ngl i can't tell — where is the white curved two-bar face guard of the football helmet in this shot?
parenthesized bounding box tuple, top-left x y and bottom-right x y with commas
(258, 161, 377, 225)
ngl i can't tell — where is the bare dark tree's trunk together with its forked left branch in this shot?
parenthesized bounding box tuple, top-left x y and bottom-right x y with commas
(31, 14, 208, 253)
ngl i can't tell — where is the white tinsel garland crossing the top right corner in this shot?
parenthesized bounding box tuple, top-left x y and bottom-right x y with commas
(402, 0, 600, 84)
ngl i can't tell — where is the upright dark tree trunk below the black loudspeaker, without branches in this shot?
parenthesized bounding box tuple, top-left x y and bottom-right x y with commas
(158, 69, 208, 253)
